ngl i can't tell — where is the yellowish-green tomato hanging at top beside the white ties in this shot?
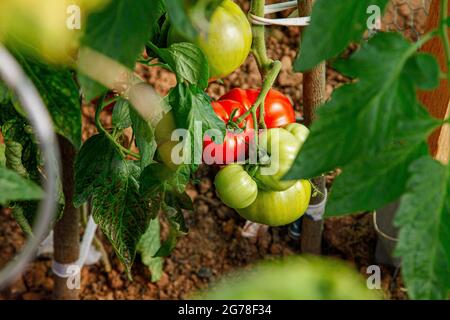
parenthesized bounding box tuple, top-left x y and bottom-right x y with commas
(167, 0, 252, 79)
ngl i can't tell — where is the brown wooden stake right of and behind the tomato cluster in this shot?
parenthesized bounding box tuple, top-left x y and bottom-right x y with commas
(298, 0, 326, 255)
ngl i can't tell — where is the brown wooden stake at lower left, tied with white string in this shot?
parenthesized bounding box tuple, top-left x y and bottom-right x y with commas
(53, 136, 80, 300)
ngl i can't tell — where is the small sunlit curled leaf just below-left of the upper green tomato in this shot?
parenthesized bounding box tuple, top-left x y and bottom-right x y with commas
(152, 42, 209, 89)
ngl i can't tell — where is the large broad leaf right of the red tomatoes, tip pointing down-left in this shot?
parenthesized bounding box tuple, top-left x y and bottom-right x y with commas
(286, 34, 439, 179)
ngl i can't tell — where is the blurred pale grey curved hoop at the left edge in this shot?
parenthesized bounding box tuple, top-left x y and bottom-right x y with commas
(0, 45, 60, 289)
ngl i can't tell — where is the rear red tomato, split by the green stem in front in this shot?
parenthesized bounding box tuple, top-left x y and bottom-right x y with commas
(220, 88, 295, 129)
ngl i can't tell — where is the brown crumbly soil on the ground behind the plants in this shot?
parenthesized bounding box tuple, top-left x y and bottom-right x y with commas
(0, 2, 422, 300)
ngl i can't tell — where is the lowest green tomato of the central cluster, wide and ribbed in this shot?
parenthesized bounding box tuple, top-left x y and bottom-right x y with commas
(236, 180, 311, 227)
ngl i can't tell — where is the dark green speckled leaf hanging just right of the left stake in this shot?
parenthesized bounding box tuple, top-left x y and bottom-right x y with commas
(74, 134, 152, 275)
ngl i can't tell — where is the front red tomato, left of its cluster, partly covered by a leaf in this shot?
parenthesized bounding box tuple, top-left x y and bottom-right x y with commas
(203, 100, 253, 164)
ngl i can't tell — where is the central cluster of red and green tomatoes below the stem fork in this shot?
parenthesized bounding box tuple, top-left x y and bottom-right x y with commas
(156, 88, 311, 226)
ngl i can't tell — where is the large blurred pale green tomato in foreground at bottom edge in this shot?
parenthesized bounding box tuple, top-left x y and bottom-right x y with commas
(206, 255, 383, 300)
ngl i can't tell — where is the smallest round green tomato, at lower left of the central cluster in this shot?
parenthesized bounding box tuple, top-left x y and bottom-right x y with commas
(214, 164, 258, 209)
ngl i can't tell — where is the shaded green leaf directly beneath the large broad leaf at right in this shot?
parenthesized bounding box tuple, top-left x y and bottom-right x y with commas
(325, 143, 428, 216)
